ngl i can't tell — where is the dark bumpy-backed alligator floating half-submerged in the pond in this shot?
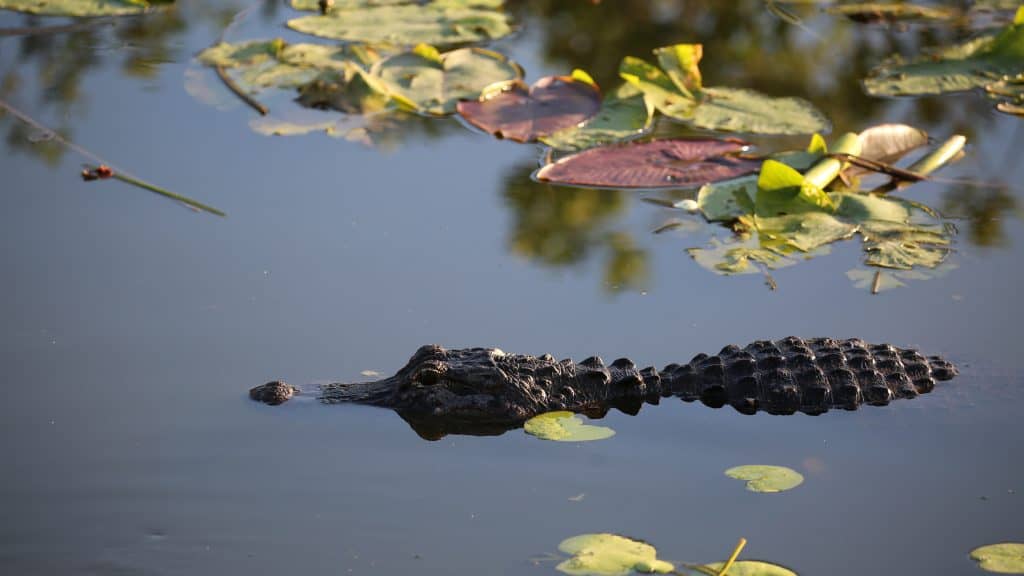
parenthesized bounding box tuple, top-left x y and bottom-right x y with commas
(249, 336, 957, 440)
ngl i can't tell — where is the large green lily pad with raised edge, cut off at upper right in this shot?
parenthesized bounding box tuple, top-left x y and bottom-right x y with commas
(864, 7, 1024, 96)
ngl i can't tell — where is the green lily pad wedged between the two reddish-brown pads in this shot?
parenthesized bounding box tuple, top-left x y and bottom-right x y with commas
(540, 84, 654, 151)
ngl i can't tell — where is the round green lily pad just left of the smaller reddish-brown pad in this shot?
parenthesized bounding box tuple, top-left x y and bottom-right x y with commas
(372, 44, 522, 116)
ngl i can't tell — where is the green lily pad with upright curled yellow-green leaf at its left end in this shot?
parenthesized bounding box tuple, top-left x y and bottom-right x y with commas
(618, 44, 829, 134)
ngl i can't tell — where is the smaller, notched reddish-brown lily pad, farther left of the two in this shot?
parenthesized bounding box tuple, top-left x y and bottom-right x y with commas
(458, 76, 601, 142)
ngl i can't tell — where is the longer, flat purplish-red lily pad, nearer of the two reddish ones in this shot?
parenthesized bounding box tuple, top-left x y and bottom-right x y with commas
(537, 138, 761, 189)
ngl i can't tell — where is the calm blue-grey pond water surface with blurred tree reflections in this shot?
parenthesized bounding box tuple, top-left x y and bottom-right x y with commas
(0, 0, 1024, 576)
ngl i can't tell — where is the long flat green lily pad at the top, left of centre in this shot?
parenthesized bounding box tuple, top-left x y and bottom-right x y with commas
(288, 2, 512, 46)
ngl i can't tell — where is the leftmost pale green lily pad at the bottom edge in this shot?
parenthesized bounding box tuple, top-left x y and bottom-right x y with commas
(556, 534, 675, 576)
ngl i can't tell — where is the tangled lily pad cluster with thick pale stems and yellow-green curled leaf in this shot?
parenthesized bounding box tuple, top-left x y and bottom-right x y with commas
(675, 125, 964, 291)
